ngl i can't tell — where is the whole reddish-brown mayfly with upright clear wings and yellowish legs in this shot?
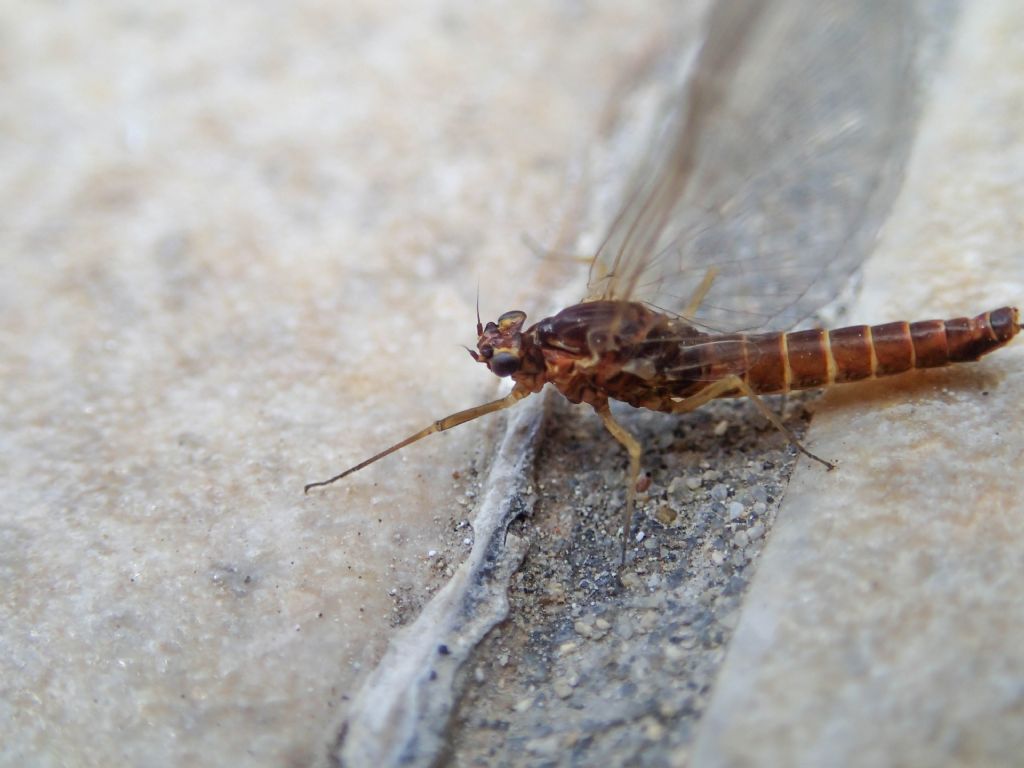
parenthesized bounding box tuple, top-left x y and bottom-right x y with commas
(305, 0, 1020, 561)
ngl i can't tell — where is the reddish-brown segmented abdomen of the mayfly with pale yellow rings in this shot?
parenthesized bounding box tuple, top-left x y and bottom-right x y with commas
(743, 307, 1020, 394)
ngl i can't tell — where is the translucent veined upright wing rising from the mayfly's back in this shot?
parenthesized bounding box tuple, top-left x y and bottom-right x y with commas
(589, 0, 919, 331)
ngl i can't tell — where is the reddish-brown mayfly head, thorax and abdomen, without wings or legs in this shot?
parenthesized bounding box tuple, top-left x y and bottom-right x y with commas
(483, 301, 1020, 413)
